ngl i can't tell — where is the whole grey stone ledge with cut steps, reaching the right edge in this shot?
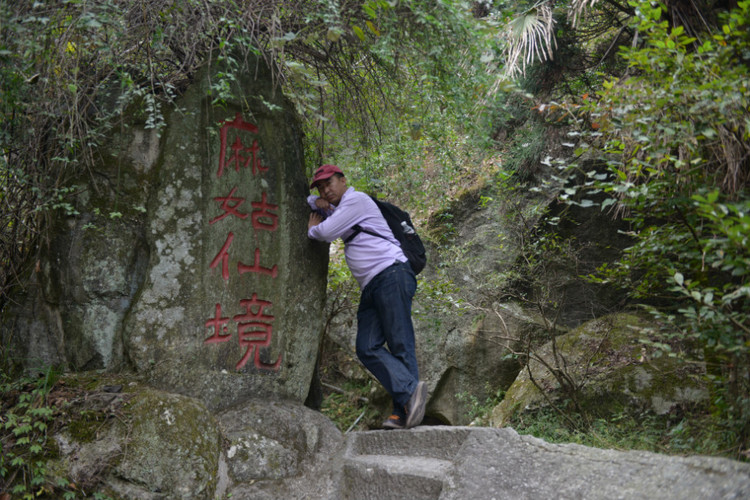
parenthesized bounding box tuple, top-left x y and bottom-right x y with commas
(334, 427, 750, 500)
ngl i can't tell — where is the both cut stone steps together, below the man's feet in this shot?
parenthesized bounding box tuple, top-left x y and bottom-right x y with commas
(339, 427, 471, 500)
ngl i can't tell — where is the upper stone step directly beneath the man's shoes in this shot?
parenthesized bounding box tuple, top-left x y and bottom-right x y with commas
(347, 426, 471, 460)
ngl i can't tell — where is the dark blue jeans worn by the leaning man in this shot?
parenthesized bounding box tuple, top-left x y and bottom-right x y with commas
(357, 262, 419, 416)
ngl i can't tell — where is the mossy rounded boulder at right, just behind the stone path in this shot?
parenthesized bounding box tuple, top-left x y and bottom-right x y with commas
(488, 313, 708, 427)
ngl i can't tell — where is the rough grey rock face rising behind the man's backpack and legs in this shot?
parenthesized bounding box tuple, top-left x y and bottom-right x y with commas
(415, 180, 628, 425)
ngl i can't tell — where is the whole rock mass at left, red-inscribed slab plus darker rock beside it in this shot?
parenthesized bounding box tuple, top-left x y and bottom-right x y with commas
(2, 52, 327, 410)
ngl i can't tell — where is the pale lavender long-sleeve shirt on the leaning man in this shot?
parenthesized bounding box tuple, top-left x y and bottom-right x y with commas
(307, 187, 407, 289)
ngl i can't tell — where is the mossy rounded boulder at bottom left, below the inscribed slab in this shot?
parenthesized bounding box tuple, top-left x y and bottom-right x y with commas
(52, 383, 222, 499)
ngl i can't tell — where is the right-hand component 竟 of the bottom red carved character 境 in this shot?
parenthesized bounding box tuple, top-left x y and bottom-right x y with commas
(234, 293, 281, 371)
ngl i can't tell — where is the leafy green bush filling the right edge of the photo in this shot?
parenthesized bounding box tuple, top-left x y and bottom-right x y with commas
(552, 1, 750, 452)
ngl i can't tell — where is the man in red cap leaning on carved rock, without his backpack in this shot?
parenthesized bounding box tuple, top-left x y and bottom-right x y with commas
(307, 165, 427, 429)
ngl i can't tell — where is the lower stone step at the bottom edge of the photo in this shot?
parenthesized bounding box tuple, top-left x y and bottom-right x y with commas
(339, 454, 453, 500)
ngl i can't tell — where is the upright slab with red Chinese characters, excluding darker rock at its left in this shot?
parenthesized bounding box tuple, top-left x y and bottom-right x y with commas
(123, 58, 326, 409)
